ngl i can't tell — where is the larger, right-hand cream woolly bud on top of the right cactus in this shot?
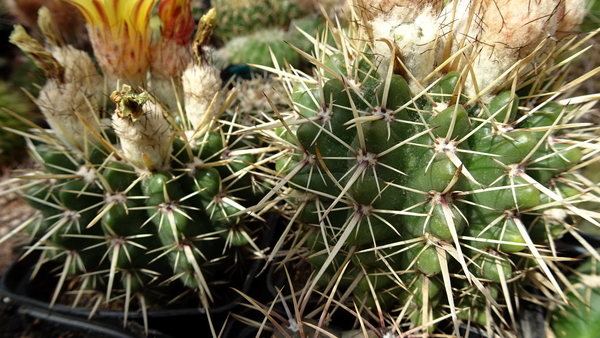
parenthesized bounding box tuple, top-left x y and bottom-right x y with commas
(440, 0, 568, 103)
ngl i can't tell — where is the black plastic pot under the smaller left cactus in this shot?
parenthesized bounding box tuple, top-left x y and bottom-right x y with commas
(0, 217, 276, 338)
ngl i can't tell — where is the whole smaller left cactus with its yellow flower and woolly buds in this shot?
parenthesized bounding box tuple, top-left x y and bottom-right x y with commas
(0, 0, 268, 336)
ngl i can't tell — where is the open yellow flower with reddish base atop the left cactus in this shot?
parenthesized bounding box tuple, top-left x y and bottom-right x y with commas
(65, 0, 157, 85)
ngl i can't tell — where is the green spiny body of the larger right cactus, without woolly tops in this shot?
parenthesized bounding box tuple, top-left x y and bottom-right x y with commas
(258, 4, 600, 332)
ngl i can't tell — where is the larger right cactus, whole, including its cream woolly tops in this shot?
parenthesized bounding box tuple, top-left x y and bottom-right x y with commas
(247, 0, 600, 337)
